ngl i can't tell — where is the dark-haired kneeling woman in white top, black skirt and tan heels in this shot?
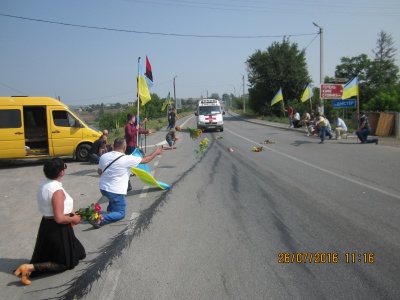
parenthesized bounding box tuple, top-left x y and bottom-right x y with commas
(14, 158, 86, 284)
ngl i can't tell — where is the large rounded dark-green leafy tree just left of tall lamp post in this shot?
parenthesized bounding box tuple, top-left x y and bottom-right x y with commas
(246, 38, 311, 115)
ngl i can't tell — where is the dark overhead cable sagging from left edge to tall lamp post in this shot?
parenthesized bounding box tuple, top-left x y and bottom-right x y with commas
(0, 14, 315, 39)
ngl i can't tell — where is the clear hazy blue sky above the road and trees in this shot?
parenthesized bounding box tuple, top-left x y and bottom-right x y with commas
(0, 0, 400, 106)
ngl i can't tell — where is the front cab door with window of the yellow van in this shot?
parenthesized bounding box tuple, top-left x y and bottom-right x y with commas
(47, 107, 83, 156)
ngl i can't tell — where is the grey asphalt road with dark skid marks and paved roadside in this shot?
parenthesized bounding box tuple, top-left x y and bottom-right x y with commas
(0, 115, 400, 299)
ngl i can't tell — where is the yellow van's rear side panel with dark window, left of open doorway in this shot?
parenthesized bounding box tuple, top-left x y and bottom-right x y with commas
(0, 106, 26, 158)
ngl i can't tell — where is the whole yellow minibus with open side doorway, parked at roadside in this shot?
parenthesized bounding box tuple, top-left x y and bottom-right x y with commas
(0, 96, 101, 161)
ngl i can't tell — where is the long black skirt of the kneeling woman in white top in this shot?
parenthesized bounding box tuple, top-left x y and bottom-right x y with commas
(30, 218, 86, 270)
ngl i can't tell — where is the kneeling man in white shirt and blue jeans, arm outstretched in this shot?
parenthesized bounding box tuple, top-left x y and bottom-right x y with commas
(91, 138, 164, 228)
